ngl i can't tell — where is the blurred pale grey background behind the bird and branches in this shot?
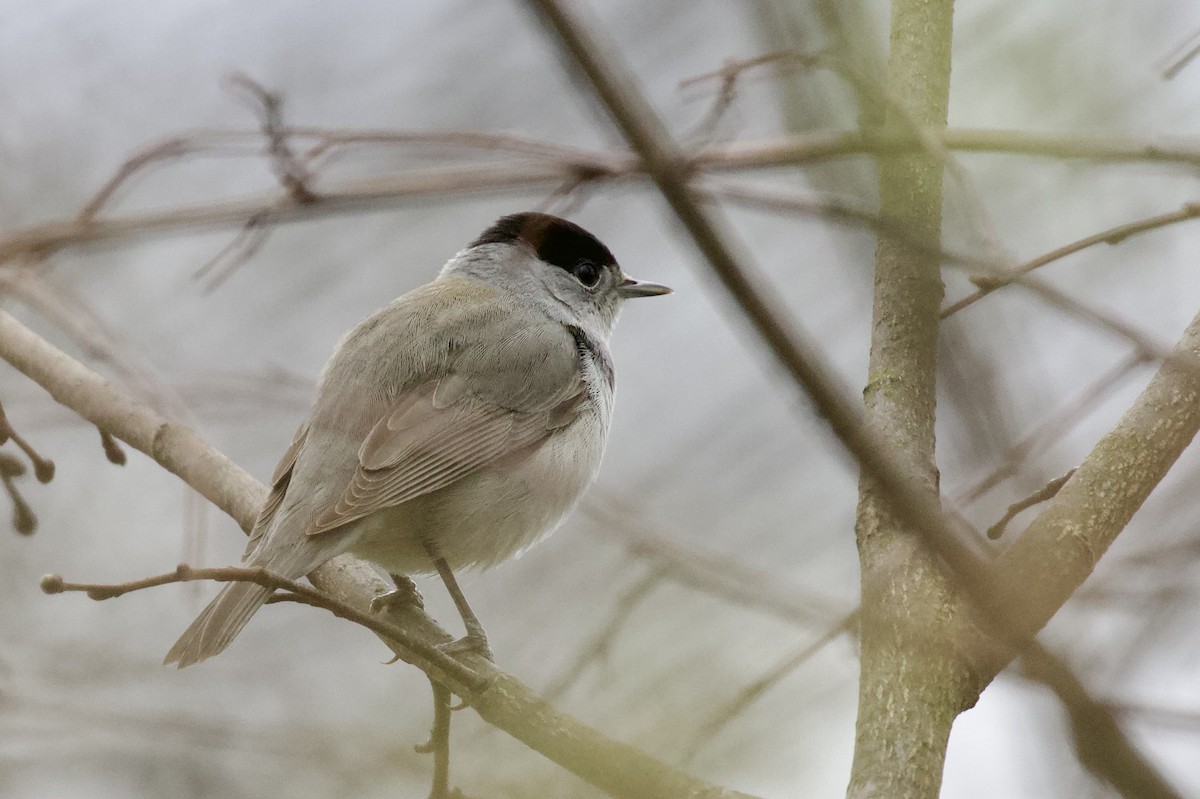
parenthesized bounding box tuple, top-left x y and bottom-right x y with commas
(0, 0, 1200, 799)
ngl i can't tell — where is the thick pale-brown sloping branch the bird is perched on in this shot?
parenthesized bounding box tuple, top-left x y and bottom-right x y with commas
(0, 311, 746, 799)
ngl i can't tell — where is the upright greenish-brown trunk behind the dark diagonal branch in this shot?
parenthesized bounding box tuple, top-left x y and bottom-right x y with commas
(847, 0, 967, 799)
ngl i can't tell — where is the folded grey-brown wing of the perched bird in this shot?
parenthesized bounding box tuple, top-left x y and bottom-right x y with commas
(306, 323, 588, 536)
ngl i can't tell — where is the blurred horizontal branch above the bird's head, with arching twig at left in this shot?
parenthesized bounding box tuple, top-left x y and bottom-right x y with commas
(7, 128, 1200, 263)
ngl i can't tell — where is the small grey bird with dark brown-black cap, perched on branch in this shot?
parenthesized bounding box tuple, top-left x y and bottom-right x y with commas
(164, 212, 671, 668)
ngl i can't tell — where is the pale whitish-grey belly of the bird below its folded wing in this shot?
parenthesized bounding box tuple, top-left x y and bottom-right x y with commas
(349, 414, 607, 575)
